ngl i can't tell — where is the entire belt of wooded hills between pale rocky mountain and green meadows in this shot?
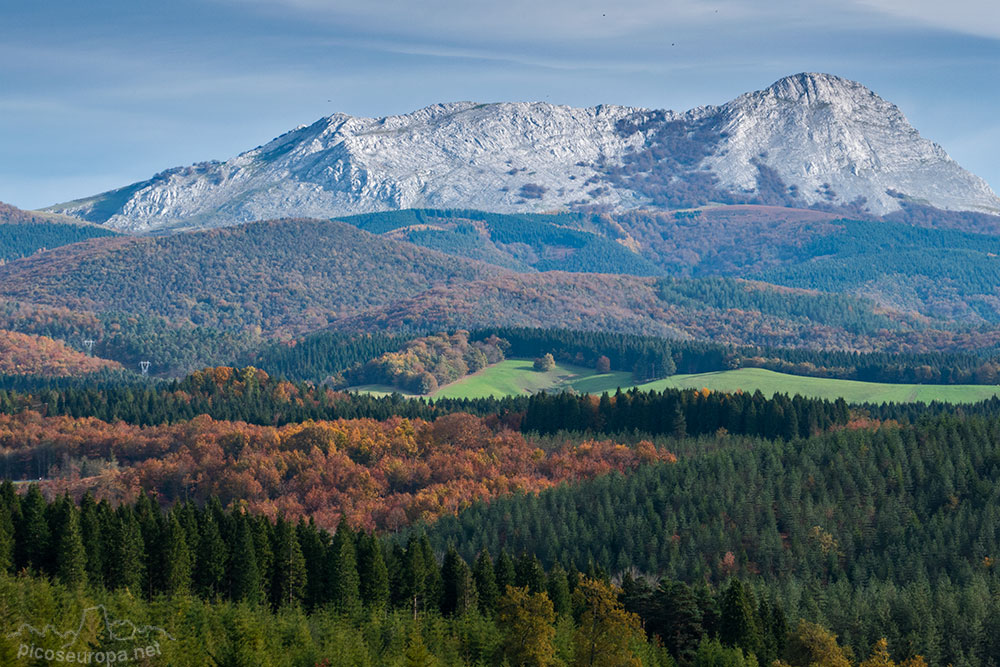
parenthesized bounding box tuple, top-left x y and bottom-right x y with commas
(0, 211, 1000, 363)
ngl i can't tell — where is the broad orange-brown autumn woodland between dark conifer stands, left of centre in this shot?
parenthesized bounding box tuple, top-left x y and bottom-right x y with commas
(0, 411, 674, 529)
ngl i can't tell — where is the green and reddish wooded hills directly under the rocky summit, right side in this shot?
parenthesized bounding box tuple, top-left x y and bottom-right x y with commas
(343, 205, 1000, 325)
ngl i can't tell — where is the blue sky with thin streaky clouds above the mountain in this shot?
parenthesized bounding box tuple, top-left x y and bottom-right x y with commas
(0, 0, 1000, 209)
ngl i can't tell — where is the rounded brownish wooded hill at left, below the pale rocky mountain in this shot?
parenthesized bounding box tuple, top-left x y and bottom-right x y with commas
(0, 220, 502, 333)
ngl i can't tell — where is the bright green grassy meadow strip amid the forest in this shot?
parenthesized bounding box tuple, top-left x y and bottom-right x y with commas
(352, 359, 1000, 403)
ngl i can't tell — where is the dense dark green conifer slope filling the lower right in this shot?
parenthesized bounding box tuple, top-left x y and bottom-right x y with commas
(429, 418, 1000, 665)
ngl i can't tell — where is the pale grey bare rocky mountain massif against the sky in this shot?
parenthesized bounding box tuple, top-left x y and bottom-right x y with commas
(49, 74, 1000, 231)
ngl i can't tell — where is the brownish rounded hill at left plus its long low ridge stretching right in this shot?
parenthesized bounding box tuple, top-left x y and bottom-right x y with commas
(0, 220, 940, 349)
